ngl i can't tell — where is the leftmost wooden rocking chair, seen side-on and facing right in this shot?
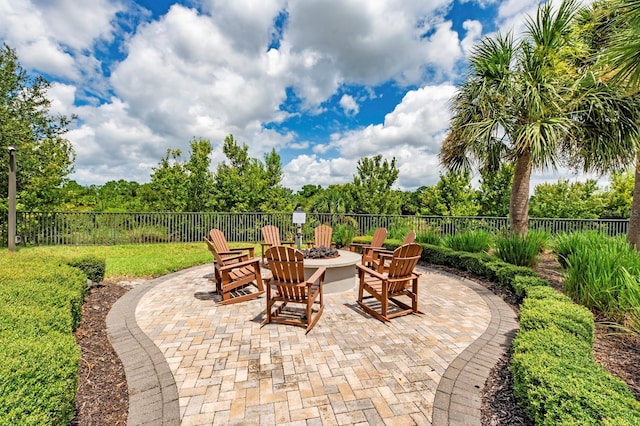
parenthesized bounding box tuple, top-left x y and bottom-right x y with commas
(204, 237, 264, 305)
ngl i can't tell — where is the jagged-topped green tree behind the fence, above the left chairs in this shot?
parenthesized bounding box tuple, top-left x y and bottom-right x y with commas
(213, 135, 293, 212)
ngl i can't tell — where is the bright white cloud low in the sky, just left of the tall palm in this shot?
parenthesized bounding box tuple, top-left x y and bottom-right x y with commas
(284, 85, 456, 189)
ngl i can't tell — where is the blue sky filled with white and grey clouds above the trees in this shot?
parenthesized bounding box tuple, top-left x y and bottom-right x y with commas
(0, 0, 600, 190)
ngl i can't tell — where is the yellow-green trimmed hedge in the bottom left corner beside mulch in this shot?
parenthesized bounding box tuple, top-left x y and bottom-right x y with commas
(0, 253, 87, 425)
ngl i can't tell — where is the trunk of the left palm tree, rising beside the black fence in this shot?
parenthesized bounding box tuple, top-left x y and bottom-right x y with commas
(509, 151, 531, 237)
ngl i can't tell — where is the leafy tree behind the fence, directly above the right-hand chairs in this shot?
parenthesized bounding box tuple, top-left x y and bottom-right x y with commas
(351, 154, 402, 214)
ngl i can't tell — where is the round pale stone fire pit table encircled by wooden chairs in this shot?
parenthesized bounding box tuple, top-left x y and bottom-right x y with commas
(304, 250, 362, 294)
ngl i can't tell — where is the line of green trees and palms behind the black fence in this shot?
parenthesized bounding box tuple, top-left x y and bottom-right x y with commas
(0, 0, 640, 244)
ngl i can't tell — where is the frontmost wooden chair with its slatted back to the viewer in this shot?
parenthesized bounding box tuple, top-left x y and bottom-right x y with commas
(262, 246, 326, 333)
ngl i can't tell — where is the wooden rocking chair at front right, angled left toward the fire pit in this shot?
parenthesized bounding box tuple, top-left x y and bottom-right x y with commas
(356, 244, 422, 322)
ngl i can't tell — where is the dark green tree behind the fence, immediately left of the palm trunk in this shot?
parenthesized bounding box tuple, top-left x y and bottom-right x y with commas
(478, 164, 513, 217)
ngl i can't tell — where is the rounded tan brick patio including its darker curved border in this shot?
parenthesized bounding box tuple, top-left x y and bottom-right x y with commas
(107, 266, 517, 425)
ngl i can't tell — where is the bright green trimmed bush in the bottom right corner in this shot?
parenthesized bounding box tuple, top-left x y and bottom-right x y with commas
(511, 328, 640, 425)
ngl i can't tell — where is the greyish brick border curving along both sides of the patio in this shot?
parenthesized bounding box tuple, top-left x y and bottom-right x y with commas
(107, 264, 518, 425)
